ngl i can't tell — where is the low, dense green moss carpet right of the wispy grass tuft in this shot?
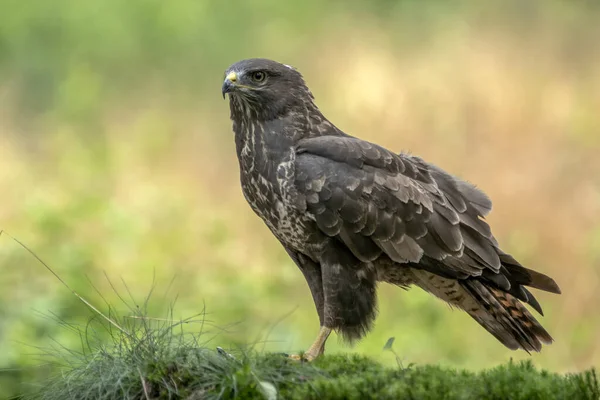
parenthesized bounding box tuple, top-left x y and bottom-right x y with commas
(282, 356, 600, 399)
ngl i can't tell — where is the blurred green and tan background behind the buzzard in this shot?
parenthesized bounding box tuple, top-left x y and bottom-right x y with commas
(0, 0, 600, 396)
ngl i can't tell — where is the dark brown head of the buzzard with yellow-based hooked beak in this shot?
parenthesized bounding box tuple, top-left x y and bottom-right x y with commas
(221, 58, 313, 120)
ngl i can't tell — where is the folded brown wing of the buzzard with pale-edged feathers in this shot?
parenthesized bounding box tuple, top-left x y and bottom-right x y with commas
(294, 136, 501, 277)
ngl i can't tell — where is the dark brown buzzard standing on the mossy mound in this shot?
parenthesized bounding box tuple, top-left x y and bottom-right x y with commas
(222, 58, 560, 361)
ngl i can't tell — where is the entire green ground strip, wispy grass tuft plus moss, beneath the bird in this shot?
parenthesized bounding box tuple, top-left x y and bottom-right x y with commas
(25, 308, 600, 400)
